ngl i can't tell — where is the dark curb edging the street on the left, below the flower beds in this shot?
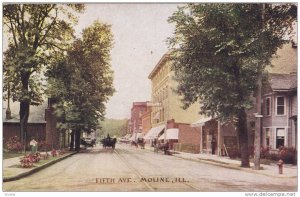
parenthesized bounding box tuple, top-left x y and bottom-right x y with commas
(3, 152, 77, 182)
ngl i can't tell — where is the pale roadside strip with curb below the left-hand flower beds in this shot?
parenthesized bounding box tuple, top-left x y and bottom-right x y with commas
(2, 152, 76, 182)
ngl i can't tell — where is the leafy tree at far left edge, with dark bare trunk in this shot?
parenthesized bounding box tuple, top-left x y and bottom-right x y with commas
(3, 4, 84, 146)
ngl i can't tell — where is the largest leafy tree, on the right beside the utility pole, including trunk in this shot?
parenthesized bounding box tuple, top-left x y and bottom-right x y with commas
(169, 3, 297, 167)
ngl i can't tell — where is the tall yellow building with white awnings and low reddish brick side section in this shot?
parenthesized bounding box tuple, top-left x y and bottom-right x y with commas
(145, 53, 200, 152)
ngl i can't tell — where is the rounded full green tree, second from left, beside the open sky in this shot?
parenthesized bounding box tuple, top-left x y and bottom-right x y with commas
(47, 21, 114, 151)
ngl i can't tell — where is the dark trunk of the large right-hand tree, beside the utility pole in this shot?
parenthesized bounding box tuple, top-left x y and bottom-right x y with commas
(237, 108, 250, 168)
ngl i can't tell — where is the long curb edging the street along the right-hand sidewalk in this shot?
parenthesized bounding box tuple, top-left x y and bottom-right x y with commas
(172, 155, 297, 178)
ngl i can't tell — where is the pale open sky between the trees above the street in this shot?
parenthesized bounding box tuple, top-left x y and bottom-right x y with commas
(75, 3, 183, 119)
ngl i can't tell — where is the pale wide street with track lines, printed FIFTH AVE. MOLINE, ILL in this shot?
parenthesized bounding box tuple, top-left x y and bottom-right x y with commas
(3, 144, 297, 192)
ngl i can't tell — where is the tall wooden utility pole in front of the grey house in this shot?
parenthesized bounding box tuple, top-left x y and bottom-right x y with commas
(254, 4, 265, 170)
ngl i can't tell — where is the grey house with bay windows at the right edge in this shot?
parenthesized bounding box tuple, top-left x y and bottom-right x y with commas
(262, 74, 297, 149)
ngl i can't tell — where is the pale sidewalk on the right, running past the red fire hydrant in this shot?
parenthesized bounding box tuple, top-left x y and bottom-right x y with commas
(145, 146, 298, 178)
